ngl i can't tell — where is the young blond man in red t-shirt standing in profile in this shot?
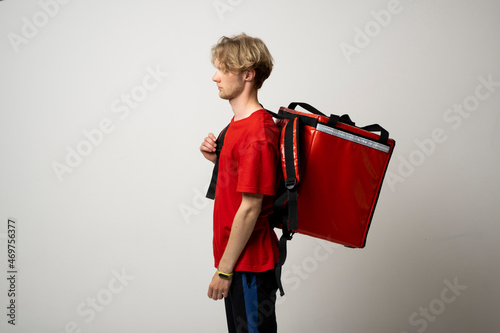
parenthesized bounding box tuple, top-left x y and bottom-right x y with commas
(200, 34, 279, 333)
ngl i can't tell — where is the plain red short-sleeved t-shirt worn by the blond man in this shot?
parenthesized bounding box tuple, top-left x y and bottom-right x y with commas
(213, 109, 279, 273)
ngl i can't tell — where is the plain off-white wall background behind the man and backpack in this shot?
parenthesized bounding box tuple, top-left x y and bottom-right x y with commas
(0, 0, 500, 333)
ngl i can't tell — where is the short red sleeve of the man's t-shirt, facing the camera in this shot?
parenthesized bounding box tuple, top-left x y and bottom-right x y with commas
(236, 141, 278, 195)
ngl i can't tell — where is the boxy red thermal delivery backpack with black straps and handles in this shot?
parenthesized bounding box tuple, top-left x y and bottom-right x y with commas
(207, 102, 396, 296)
